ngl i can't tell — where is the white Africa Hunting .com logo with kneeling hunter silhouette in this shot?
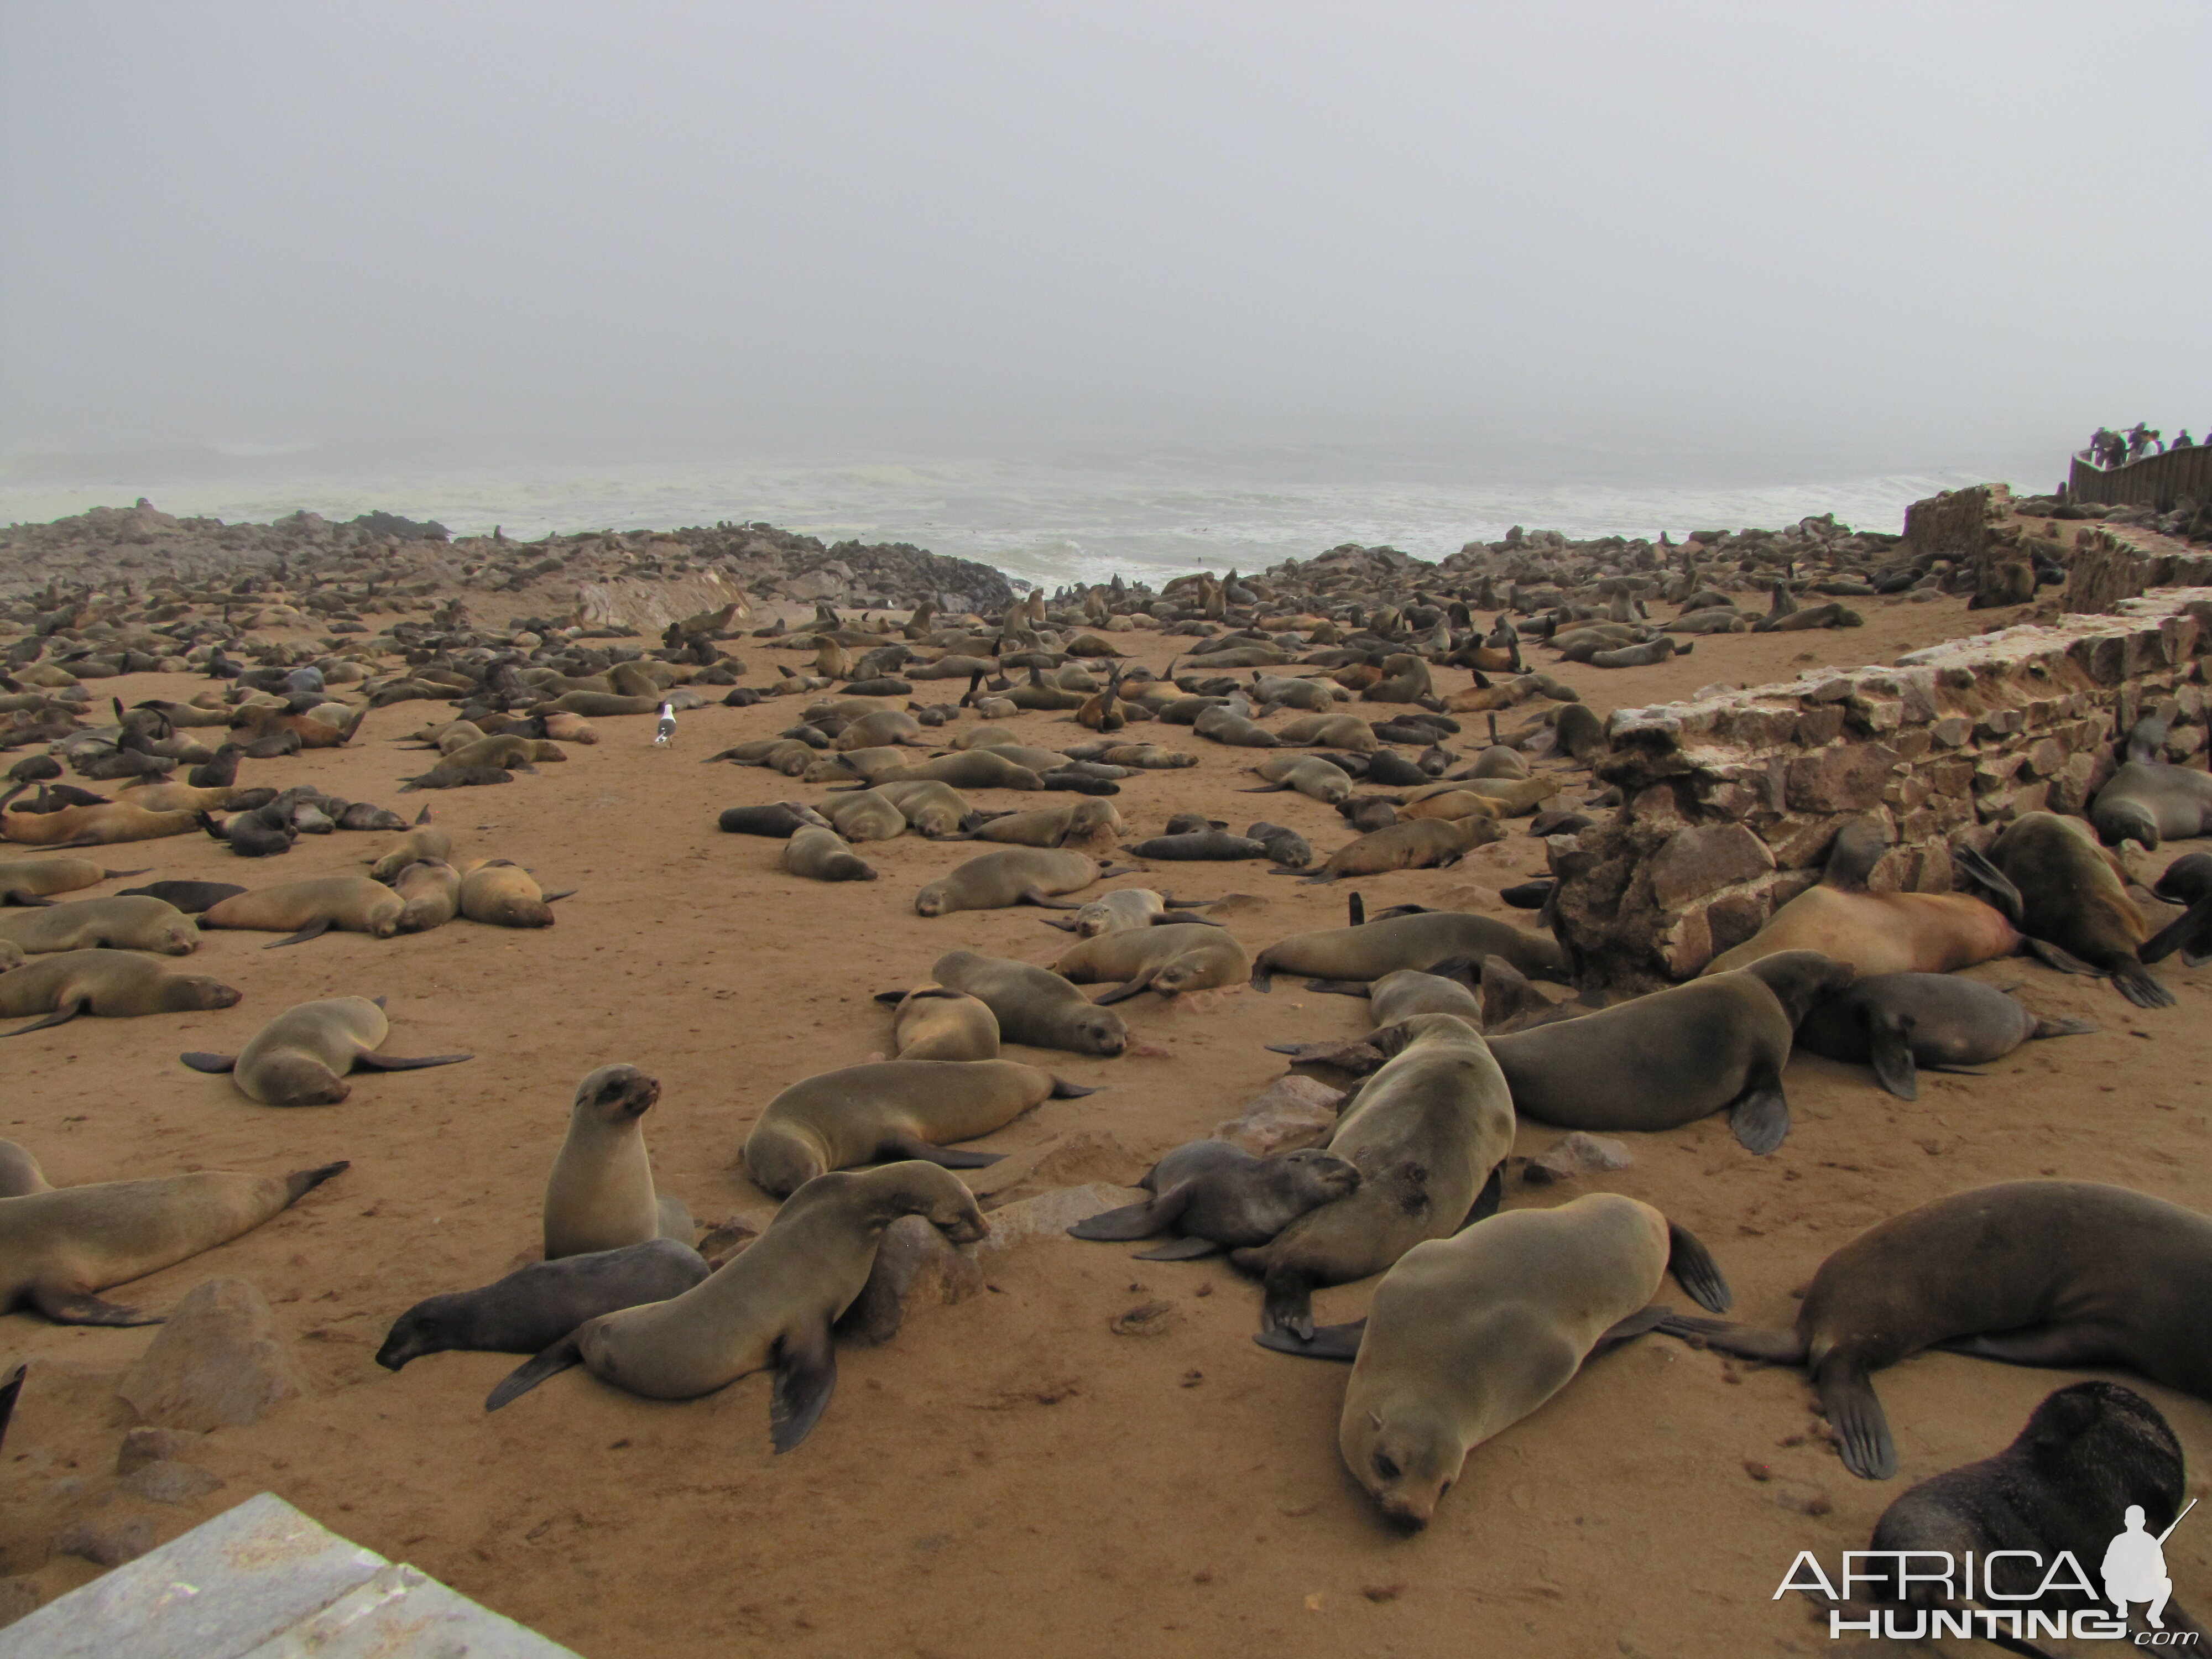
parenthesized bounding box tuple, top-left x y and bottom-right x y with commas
(1774, 1498, 2199, 1652)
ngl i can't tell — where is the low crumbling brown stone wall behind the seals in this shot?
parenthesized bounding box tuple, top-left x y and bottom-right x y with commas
(1551, 588, 2212, 989)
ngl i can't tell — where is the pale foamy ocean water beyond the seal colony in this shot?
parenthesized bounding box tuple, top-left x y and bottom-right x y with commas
(0, 445, 2048, 586)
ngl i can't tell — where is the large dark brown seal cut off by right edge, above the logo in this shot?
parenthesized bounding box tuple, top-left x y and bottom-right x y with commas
(1663, 1181, 2212, 1480)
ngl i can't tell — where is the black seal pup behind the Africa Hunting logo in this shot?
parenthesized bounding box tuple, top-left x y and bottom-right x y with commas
(1869, 1383, 2197, 1646)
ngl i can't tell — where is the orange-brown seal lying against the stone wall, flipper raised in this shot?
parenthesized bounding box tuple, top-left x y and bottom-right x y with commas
(1703, 818, 2020, 978)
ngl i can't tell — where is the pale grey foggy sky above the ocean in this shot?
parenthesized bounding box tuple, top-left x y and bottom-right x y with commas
(0, 0, 2212, 465)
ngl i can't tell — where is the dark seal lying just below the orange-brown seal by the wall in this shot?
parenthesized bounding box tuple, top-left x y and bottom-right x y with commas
(1767, 973, 2097, 1099)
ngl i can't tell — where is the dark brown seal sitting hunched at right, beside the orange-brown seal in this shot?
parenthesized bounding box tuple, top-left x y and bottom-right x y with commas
(1955, 812, 2174, 1009)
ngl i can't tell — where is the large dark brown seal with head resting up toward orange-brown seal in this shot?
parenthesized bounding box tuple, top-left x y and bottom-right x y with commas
(1491, 951, 1856, 1152)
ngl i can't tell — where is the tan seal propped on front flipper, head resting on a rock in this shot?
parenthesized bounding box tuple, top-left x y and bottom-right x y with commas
(498, 1164, 989, 1451)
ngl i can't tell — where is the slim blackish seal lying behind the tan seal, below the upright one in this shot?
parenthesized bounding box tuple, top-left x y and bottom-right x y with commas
(376, 1239, 708, 1371)
